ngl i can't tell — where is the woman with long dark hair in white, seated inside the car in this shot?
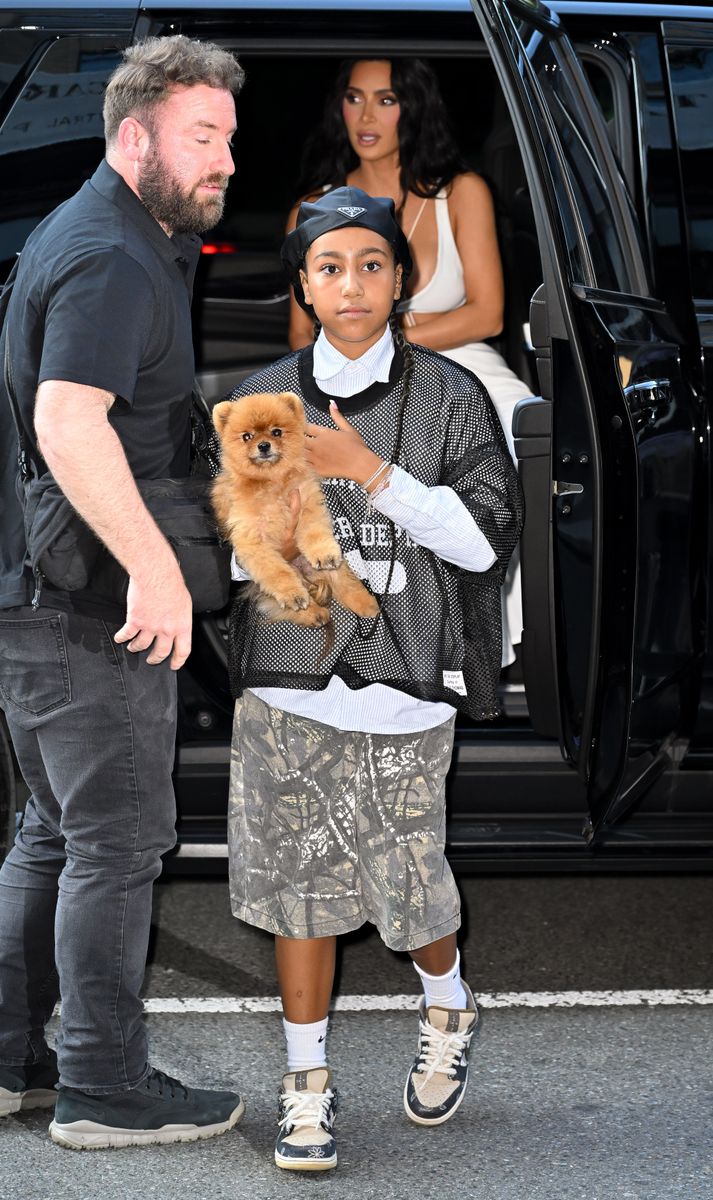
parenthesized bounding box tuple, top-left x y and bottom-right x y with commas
(287, 59, 531, 665)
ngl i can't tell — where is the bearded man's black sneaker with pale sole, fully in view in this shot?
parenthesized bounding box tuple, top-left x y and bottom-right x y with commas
(49, 1069, 245, 1150)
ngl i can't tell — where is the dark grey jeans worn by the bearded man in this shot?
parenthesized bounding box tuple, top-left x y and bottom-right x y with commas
(0, 608, 176, 1093)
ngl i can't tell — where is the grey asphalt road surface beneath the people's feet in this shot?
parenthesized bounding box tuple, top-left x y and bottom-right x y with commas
(0, 876, 713, 1200)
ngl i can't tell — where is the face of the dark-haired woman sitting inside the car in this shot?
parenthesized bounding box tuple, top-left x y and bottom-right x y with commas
(342, 59, 401, 162)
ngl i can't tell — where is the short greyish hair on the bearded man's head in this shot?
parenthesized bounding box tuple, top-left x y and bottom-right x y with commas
(104, 34, 245, 144)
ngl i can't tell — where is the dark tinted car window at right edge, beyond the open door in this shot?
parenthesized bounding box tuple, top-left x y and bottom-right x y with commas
(669, 43, 713, 301)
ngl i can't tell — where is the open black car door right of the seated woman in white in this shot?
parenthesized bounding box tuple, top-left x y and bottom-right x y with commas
(465, 0, 702, 838)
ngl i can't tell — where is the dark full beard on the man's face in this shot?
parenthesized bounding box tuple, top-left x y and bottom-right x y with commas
(137, 146, 228, 233)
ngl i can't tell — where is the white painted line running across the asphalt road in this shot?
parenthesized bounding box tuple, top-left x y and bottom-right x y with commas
(144, 988, 713, 1014)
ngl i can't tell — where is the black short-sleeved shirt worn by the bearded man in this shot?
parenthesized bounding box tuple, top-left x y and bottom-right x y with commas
(0, 161, 200, 616)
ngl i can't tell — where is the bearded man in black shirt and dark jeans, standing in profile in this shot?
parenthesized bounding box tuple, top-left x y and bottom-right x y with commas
(0, 36, 244, 1148)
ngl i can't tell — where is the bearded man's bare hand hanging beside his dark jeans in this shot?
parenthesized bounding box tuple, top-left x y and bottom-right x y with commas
(114, 563, 193, 671)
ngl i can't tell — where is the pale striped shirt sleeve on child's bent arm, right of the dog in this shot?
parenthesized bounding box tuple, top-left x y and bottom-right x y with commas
(372, 467, 497, 571)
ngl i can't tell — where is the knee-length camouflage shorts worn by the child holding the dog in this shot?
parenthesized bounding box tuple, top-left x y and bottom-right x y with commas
(228, 691, 460, 950)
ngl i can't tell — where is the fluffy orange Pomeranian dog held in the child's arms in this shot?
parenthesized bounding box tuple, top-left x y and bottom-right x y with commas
(212, 391, 379, 628)
